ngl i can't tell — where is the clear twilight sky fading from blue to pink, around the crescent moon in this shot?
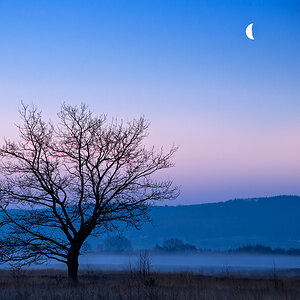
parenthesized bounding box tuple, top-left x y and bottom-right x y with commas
(0, 0, 300, 204)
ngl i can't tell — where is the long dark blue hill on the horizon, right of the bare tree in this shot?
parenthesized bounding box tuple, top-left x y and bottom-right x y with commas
(90, 196, 300, 250)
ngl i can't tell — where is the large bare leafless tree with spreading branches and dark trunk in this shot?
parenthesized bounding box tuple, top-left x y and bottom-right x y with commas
(0, 105, 179, 281)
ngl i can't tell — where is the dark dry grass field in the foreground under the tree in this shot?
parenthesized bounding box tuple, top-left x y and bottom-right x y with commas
(0, 270, 300, 300)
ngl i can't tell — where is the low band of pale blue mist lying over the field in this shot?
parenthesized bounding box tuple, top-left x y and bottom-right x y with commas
(1, 253, 300, 275)
